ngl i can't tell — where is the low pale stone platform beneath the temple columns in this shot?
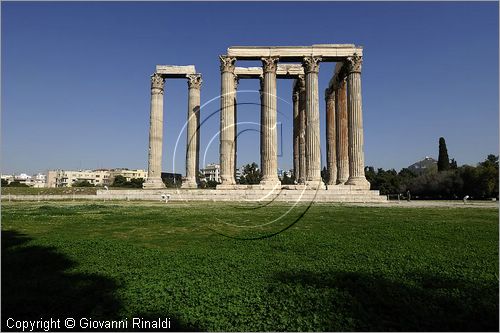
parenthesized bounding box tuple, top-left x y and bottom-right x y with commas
(97, 185, 387, 203)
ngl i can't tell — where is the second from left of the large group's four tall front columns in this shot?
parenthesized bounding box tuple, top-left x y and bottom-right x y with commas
(260, 57, 281, 188)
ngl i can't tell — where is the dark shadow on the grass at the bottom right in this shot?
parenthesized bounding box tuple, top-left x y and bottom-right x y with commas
(277, 272, 499, 332)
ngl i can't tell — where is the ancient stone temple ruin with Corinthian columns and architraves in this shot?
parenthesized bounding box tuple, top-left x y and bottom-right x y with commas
(137, 44, 384, 201)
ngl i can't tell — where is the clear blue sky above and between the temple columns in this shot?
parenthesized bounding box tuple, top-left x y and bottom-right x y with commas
(1, 2, 499, 173)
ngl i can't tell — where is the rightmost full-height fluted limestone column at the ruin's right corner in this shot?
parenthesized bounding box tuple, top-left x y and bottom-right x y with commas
(346, 54, 370, 189)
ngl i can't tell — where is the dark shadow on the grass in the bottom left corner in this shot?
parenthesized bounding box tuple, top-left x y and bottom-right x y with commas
(1, 230, 197, 331)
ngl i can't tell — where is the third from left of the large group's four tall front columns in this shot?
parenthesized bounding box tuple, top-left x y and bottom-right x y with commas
(303, 56, 325, 189)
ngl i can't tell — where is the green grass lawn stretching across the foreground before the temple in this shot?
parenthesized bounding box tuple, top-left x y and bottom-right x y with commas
(1, 202, 499, 331)
